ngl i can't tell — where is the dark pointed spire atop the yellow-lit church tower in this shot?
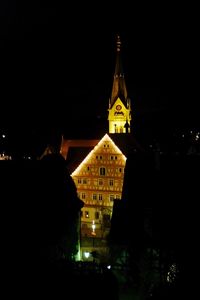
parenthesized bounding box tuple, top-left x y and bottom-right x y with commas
(110, 35, 127, 107)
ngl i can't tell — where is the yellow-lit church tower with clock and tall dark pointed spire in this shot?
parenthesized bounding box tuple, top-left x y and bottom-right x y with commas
(108, 35, 131, 133)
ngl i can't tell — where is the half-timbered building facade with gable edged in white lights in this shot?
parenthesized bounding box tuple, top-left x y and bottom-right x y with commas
(71, 134, 126, 259)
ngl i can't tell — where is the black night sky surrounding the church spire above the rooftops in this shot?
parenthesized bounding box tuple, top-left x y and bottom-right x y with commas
(0, 0, 199, 149)
